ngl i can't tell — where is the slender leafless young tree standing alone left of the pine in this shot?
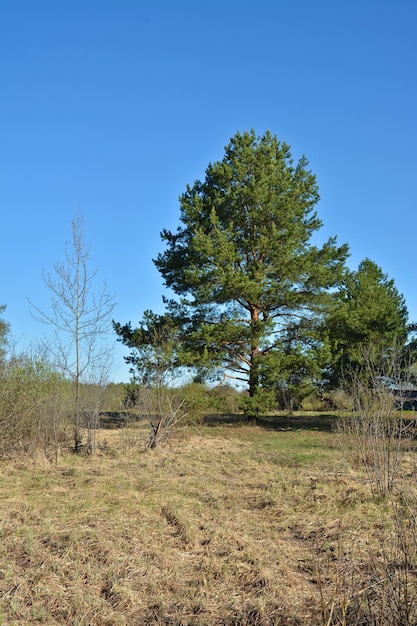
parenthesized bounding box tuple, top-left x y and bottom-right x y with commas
(31, 212, 115, 452)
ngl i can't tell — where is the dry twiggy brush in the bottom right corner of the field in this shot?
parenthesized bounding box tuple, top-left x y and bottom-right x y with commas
(317, 488, 417, 626)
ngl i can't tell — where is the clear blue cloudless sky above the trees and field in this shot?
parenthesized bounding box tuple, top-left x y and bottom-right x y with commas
(0, 0, 417, 380)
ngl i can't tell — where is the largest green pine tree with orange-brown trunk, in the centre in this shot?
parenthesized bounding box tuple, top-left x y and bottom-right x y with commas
(151, 131, 348, 397)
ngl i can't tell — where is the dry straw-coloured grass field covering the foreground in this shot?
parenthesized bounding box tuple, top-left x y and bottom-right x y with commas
(0, 416, 417, 626)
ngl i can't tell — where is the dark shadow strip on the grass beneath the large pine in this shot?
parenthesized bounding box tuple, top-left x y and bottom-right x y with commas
(203, 413, 338, 432)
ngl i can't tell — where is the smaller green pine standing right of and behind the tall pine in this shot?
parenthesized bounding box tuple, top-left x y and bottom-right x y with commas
(326, 259, 408, 387)
